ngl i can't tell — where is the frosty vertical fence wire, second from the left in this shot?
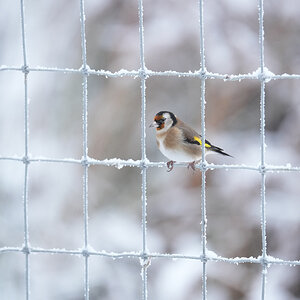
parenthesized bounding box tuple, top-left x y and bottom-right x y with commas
(80, 0, 89, 300)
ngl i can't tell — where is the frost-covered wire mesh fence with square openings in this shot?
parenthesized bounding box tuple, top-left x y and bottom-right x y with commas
(0, 0, 300, 300)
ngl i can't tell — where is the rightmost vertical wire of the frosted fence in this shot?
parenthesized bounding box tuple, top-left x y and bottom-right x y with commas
(258, 0, 267, 300)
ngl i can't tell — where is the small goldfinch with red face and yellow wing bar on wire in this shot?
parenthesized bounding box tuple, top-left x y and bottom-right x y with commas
(150, 111, 232, 172)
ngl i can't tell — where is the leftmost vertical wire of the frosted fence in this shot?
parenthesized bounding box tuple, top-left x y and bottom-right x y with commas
(20, 0, 30, 300)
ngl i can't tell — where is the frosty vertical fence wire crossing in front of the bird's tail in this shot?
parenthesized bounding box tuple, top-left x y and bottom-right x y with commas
(199, 0, 207, 300)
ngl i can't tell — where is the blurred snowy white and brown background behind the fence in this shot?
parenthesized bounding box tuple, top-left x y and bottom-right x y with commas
(0, 0, 300, 300)
